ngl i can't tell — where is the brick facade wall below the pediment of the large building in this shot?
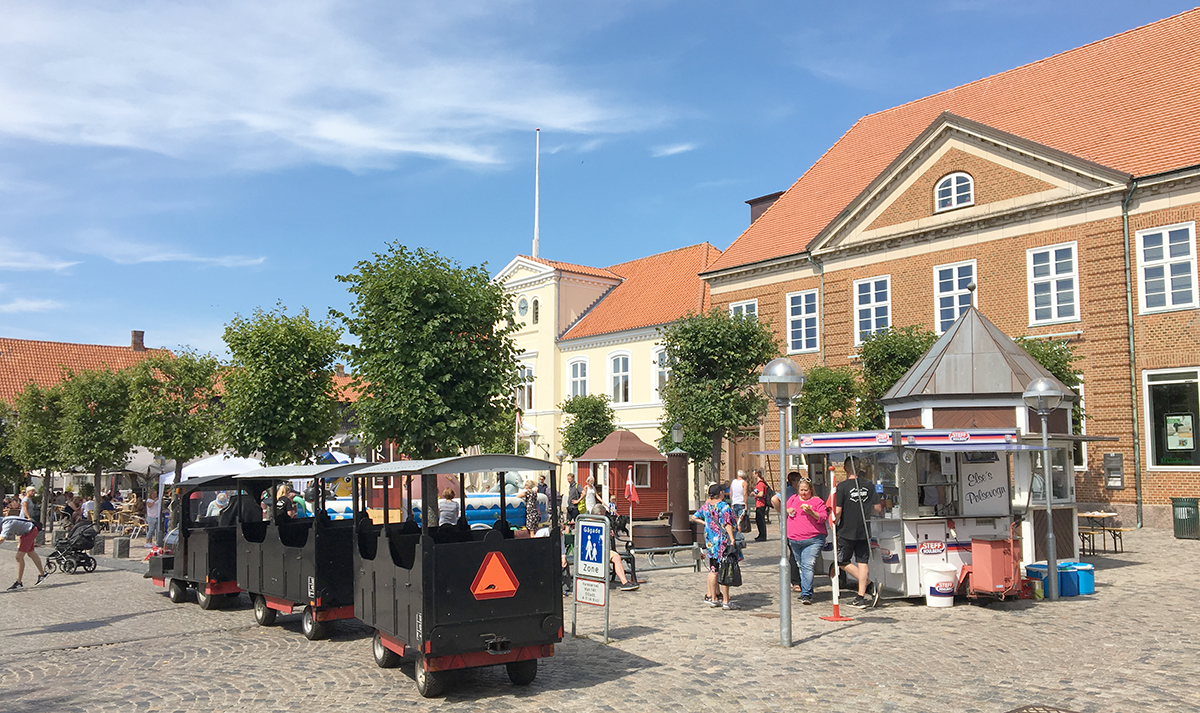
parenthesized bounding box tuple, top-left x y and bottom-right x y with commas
(713, 198, 1200, 505)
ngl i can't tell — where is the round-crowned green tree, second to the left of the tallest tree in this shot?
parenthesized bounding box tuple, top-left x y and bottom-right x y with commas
(125, 352, 220, 544)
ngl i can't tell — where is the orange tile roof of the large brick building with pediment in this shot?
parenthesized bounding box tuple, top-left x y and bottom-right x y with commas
(709, 10, 1200, 271)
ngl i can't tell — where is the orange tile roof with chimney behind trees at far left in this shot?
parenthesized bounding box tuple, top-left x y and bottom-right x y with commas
(0, 337, 170, 403)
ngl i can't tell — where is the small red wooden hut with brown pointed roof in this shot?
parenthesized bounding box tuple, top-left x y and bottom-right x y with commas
(575, 431, 667, 520)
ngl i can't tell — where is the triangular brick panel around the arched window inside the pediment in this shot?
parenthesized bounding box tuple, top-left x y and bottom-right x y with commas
(868, 149, 1054, 229)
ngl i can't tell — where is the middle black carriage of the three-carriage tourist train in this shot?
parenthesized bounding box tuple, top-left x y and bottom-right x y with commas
(238, 463, 365, 640)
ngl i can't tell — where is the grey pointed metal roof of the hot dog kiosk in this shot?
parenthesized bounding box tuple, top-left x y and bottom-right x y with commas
(880, 306, 1076, 403)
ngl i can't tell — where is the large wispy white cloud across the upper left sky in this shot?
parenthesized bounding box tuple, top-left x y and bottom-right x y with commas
(0, 0, 661, 168)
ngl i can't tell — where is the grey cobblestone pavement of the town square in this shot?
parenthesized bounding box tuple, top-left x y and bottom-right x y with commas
(0, 531, 1200, 713)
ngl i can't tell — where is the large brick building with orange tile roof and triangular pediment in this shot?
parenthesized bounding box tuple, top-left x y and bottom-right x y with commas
(702, 11, 1200, 525)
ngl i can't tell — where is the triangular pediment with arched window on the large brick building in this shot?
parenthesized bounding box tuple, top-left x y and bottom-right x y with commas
(810, 114, 1129, 254)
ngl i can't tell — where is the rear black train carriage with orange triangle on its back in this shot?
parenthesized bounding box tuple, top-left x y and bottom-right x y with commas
(353, 455, 563, 697)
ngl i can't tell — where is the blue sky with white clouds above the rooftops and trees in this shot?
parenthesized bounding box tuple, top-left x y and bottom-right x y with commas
(0, 0, 1189, 353)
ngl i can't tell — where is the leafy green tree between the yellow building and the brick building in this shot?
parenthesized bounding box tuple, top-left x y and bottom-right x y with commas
(659, 307, 779, 499)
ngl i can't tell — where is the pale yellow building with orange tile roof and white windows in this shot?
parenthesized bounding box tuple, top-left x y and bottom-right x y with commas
(496, 242, 721, 496)
